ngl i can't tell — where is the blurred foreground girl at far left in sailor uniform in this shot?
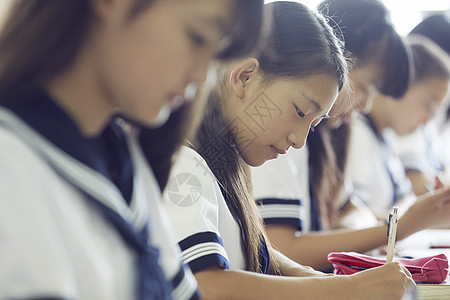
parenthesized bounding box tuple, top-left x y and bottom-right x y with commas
(0, 0, 262, 299)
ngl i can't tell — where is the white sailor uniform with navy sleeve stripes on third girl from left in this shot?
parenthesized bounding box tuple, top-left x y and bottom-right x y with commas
(252, 145, 378, 234)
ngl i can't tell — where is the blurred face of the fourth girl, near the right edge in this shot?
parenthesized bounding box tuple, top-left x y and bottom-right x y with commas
(391, 77, 449, 135)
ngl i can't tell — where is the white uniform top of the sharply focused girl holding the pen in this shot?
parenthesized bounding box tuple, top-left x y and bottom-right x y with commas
(163, 147, 269, 273)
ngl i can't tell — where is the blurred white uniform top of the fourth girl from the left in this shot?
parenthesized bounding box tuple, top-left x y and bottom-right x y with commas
(347, 115, 412, 218)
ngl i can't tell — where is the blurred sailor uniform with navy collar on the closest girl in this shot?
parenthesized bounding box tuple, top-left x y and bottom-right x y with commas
(0, 89, 198, 299)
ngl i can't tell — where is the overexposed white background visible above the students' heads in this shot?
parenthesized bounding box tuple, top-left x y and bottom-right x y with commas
(265, 0, 450, 35)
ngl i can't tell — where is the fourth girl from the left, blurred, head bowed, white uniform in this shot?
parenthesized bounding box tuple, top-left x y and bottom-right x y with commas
(348, 37, 450, 219)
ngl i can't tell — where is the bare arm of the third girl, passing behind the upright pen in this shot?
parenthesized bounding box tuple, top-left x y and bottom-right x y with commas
(266, 188, 450, 269)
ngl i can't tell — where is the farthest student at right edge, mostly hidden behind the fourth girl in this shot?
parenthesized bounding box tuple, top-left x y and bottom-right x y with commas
(386, 14, 450, 195)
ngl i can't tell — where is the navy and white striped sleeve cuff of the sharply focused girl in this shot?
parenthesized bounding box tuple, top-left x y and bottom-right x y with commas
(179, 231, 230, 273)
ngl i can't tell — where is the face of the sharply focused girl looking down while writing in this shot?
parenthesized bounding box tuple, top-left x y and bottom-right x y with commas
(226, 74, 338, 166)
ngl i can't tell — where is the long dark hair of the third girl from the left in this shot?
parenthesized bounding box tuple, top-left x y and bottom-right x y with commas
(307, 0, 412, 228)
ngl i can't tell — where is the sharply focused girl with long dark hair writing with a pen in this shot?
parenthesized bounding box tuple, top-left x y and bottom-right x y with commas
(164, 1, 411, 299)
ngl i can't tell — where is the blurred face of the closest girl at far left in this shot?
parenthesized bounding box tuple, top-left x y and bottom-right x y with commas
(91, 0, 234, 125)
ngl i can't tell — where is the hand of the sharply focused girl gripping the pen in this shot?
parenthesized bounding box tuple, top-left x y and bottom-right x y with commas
(348, 262, 415, 299)
